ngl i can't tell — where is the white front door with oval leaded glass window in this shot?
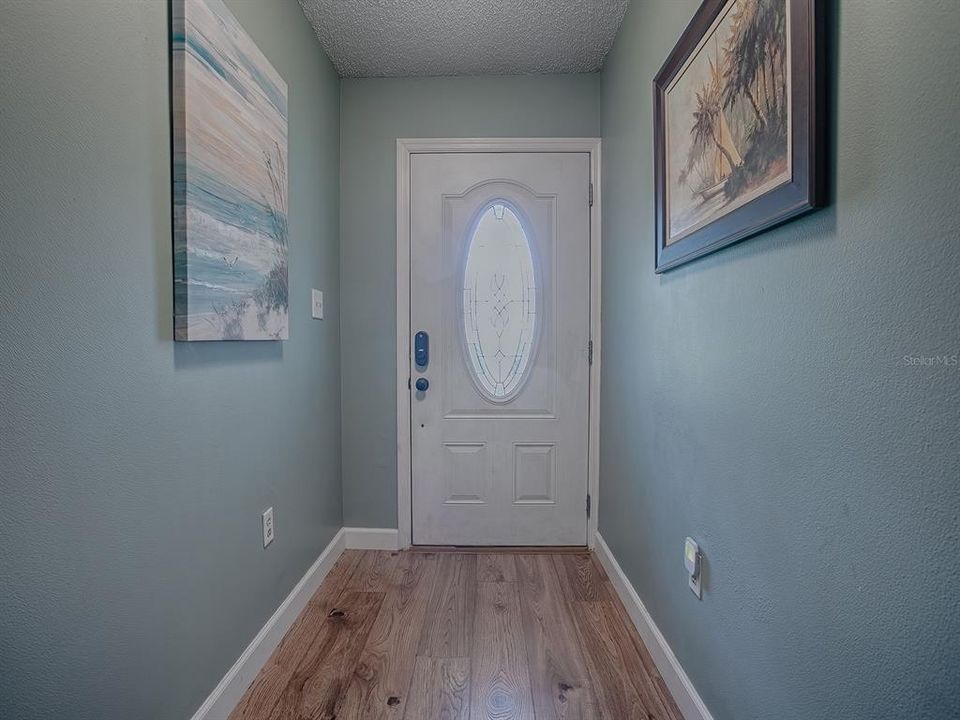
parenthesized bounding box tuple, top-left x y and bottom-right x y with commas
(410, 152, 590, 545)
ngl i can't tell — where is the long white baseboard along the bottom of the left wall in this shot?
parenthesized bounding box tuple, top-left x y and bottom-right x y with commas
(192, 528, 346, 720)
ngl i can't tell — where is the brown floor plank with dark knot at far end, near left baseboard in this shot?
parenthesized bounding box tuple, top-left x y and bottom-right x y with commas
(266, 590, 384, 720)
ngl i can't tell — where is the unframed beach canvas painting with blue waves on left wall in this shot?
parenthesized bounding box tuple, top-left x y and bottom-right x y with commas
(171, 0, 289, 340)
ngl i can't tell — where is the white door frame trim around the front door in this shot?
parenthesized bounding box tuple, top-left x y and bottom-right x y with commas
(397, 138, 602, 549)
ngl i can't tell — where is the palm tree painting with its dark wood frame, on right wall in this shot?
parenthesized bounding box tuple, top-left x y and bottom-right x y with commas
(654, 0, 826, 272)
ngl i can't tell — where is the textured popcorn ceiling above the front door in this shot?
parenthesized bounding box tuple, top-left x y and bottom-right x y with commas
(300, 0, 629, 77)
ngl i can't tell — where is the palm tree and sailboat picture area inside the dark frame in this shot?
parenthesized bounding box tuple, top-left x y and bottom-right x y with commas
(666, 0, 790, 244)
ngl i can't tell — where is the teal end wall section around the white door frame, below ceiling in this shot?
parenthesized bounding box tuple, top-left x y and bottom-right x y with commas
(340, 75, 599, 527)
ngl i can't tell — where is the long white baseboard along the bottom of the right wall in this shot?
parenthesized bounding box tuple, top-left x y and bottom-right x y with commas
(595, 533, 713, 720)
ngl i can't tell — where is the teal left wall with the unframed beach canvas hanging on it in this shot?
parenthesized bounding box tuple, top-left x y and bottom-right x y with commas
(0, 0, 341, 720)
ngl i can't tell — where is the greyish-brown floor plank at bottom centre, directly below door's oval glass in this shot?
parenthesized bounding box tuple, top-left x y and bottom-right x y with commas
(470, 582, 535, 720)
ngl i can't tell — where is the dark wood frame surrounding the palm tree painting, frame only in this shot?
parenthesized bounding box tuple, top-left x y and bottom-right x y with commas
(653, 0, 827, 273)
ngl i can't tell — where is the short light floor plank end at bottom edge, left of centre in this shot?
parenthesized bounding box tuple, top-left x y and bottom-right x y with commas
(403, 657, 470, 720)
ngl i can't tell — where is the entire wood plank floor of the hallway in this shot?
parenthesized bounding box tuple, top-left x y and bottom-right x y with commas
(230, 548, 683, 720)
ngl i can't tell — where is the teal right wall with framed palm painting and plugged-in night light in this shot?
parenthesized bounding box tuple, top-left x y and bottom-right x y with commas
(599, 0, 960, 720)
